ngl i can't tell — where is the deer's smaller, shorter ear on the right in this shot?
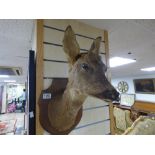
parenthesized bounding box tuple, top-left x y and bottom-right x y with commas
(89, 37, 102, 54)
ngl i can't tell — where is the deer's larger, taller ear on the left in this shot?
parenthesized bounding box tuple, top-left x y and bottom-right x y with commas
(63, 25, 80, 64)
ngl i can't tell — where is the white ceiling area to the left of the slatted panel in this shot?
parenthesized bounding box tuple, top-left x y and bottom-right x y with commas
(0, 19, 34, 82)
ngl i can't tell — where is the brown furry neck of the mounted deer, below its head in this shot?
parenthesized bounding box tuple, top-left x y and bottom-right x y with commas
(48, 80, 86, 131)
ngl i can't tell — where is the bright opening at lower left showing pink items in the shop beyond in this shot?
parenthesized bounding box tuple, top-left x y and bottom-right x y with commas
(0, 82, 27, 135)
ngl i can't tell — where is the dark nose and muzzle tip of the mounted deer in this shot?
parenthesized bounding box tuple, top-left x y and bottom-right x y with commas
(104, 89, 120, 101)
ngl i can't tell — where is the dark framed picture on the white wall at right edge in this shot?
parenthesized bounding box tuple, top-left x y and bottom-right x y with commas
(133, 78, 155, 94)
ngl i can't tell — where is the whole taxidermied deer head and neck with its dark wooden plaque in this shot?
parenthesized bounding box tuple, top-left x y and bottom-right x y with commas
(39, 26, 119, 134)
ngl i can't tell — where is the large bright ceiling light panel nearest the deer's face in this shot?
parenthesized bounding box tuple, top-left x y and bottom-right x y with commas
(110, 57, 136, 67)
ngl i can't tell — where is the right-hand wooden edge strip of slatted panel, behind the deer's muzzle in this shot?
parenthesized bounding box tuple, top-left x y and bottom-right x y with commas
(104, 31, 115, 135)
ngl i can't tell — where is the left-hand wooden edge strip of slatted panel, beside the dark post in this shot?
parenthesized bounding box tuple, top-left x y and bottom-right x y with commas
(36, 19, 44, 135)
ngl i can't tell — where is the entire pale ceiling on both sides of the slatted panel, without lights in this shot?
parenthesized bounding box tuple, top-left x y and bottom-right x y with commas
(0, 19, 155, 81)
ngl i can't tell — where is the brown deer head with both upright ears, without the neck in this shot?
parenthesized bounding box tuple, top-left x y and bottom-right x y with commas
(63, 26, 119, 100)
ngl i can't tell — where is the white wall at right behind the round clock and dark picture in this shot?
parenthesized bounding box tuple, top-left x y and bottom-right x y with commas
(112, 74, 155, 103)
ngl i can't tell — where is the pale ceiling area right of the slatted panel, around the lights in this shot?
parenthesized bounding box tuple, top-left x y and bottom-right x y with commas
(80, 19, 155, 78)
